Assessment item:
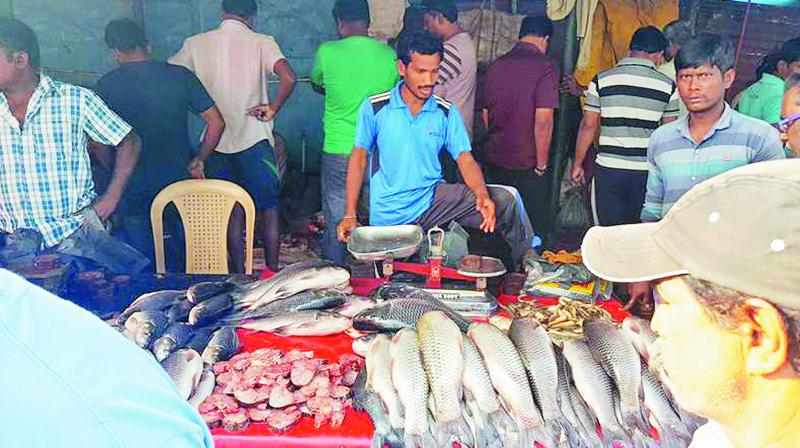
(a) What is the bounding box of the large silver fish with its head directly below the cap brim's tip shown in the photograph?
[583,319,650,439]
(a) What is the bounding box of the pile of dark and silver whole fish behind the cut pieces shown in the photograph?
[112,261,358,405]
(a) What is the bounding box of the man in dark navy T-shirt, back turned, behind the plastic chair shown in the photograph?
[96,19,225,271]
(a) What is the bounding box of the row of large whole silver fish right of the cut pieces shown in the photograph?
[353,286,700,448]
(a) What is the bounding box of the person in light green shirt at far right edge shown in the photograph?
[737,38,800,125]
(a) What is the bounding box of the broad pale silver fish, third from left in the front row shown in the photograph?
[417,311,473,445]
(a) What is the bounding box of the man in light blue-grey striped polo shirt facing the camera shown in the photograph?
[641,33,785,222]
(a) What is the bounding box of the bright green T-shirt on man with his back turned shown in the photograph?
[311,36,399,155]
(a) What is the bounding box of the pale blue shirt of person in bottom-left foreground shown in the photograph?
[0,270,213,448]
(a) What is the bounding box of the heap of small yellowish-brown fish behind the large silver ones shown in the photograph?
[504,297,613,338]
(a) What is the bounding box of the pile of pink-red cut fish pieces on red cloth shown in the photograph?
[199,349,363,431]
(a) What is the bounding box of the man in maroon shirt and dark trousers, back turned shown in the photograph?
[480,17,559,242]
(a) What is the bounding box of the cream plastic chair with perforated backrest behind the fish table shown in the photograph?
[150,179,256,275]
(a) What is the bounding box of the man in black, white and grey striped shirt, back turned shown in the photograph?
[572,26,679,226]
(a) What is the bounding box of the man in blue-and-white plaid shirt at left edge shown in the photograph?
[0,18,149,272]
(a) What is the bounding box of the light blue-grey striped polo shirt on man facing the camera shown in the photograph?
[642,104,785,222]
